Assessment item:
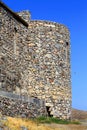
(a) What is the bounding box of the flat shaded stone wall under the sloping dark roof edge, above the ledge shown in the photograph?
[0,5,28,92]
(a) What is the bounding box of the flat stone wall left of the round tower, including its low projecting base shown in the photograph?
[0,4,46,118]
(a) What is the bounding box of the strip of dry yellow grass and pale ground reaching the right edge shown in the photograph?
[1,117,87,130]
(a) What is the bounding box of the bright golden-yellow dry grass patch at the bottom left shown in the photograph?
[4,117,56,130]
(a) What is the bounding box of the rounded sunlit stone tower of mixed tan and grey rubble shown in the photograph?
[28,21,71,119]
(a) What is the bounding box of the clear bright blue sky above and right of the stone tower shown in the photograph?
[3,0,87,110]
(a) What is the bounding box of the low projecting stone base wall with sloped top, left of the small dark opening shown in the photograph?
[0,93,47,118]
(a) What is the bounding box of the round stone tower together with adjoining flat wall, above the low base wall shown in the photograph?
[0,1,71,119]
